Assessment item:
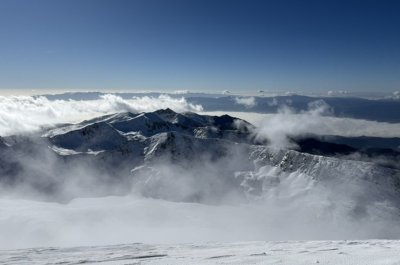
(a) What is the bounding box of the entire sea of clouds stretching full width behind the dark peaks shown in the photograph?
[0,94,400,140]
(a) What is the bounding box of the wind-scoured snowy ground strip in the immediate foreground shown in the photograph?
[0,240,400,265]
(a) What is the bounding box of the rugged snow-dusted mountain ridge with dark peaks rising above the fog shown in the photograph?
[0,109,400,211]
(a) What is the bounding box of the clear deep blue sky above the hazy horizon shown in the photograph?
[0,0,400,92]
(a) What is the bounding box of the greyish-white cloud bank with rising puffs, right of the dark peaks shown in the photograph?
[250,100,400,148]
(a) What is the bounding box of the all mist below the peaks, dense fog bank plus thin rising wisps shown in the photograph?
[0,132,400,248]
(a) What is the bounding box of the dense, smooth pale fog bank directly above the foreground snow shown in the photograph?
[0,189,400,249]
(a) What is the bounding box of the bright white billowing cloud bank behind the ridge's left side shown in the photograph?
[0,94,202,136]
